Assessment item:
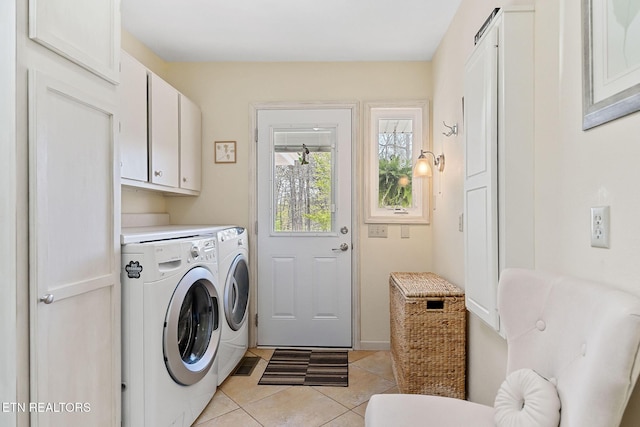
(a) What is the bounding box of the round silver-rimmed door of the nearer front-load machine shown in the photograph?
[163,267,221,385]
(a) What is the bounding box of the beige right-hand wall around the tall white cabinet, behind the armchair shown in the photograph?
[433,0,640,426]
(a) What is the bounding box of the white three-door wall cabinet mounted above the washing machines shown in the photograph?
[118,51,202,196]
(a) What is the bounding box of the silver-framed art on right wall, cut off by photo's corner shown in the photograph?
[582,0,640,130]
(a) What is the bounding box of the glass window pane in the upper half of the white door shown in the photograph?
[272,127,336,233]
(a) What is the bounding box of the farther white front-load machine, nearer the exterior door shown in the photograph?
[217,226,249,385]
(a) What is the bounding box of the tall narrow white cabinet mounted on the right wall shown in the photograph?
[464,7,534,331]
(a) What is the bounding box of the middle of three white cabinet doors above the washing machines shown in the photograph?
[149,74,179,187]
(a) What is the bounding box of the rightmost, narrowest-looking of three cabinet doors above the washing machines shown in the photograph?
[180,95,202,191]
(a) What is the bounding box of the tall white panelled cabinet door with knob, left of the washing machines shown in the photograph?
[28,70,121,427]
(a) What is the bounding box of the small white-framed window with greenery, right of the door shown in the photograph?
[364,101,429,224]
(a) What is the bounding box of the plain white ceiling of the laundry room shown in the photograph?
[121,0,461,62]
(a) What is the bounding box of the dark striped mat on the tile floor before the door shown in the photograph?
[258,349,349,387]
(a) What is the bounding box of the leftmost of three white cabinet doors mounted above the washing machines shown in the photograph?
[118,52,149,181]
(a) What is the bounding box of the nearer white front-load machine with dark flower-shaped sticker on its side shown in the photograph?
[121,227,224,427]
